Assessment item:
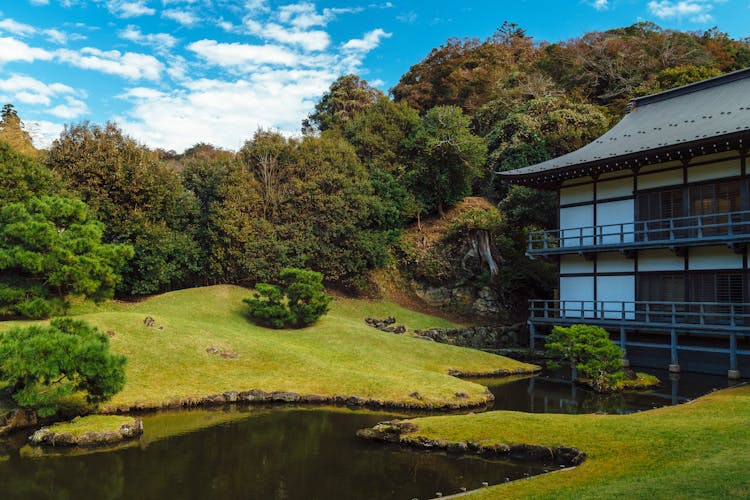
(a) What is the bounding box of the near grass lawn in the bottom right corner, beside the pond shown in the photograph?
[394,386,750,499]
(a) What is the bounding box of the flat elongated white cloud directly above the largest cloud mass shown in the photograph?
[187,39,302,67]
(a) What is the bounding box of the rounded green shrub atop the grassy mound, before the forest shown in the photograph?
[244,268,333,328]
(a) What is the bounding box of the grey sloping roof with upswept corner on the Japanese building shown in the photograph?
[498,68,750,185]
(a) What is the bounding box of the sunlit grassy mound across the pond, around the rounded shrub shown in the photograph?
[0,286,535,410]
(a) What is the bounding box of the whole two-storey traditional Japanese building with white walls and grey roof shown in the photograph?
[500,68,750,378]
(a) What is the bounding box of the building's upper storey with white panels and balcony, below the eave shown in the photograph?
[528,150,750,257]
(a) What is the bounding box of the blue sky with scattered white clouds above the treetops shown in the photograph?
[0,0,750,151]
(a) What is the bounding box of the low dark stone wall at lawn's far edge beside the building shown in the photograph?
[414,323,528,349]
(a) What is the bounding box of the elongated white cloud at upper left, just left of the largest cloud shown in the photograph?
[56,47,164,81]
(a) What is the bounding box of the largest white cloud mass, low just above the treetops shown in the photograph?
[118,70,337,151]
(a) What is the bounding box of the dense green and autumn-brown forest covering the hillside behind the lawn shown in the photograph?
[0,23,750,317]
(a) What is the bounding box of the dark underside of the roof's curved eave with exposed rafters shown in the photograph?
[497,130,750,189]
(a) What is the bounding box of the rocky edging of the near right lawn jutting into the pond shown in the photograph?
[357,420,586,467]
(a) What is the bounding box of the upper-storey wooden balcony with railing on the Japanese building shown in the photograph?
[526,210,750,258]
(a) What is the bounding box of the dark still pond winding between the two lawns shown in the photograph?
[0,374,727,500]
